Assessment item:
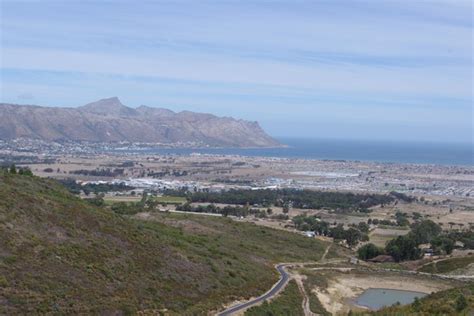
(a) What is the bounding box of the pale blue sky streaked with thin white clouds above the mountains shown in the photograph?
[0,0,474,143]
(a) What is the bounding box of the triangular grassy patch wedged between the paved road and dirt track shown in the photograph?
[245,281,304,316]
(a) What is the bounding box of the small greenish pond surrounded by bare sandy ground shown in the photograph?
[355,289,427,310]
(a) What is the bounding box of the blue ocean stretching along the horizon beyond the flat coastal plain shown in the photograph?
[121,138,474,166]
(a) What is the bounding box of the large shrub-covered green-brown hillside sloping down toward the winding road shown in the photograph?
[0,172,324,314]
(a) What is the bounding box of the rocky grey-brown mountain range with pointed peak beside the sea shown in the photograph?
[0,97,281,147]
